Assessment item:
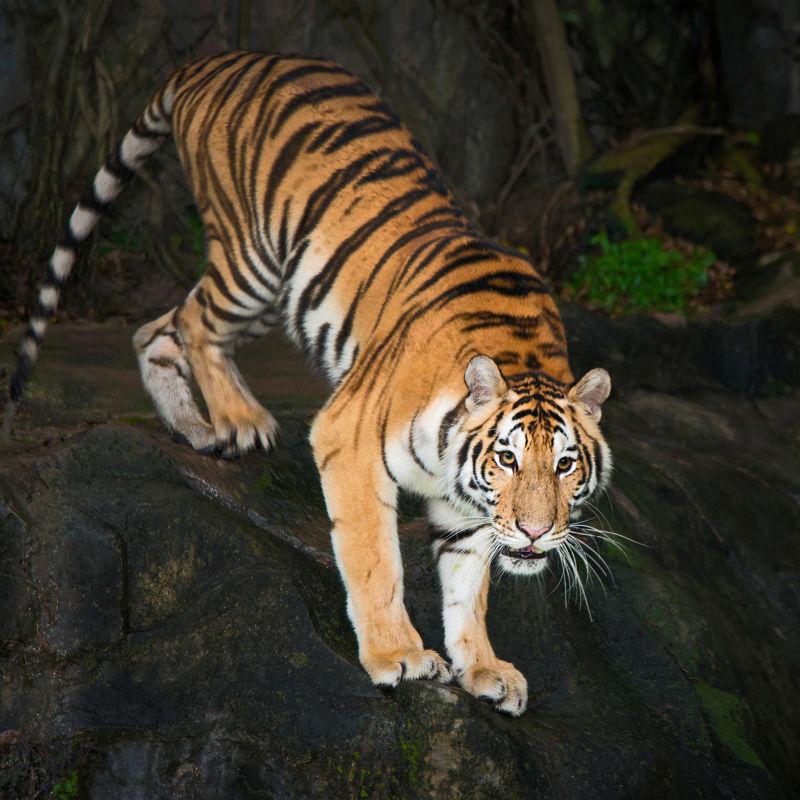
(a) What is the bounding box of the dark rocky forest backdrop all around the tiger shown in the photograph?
[0,0,800,800]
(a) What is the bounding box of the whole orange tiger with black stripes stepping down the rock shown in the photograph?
[4,52,612,716]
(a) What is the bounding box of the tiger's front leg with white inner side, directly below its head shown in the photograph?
[429,501,528,717]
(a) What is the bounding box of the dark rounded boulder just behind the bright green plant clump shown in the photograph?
[639,180,755,268]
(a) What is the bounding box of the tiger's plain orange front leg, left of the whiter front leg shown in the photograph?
[311,404,451,686]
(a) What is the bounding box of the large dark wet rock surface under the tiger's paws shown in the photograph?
[0,309,800,800]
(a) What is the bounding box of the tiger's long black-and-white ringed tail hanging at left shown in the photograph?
[2,75,178,438]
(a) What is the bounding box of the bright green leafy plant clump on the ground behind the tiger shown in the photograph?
[568,230,717,314]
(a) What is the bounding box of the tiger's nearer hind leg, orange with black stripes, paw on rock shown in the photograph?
[176,240,278,456]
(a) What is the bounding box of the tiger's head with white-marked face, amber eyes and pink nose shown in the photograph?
[448,356,612,575]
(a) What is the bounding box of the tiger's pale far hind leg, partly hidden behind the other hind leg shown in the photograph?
[133,308,216,450]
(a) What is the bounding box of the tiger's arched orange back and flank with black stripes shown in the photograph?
[173,53,566,396]
